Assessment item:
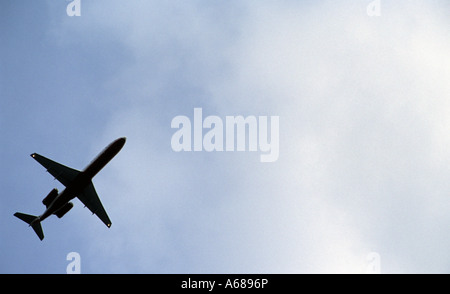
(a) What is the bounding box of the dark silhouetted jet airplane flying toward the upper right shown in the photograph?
[14,137,126,241]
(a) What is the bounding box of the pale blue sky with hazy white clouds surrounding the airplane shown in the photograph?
[0,0,450,274]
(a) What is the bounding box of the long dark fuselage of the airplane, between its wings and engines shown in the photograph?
[35,138,126,222]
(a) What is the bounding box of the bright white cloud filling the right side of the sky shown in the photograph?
[206,3,450,272]
